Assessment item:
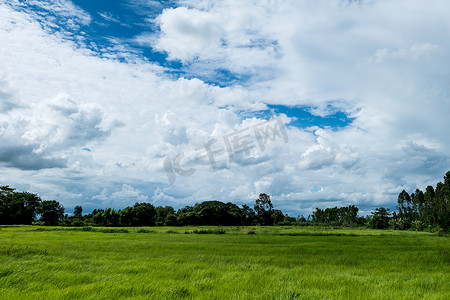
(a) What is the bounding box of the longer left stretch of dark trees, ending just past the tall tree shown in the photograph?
[0,191,296,226]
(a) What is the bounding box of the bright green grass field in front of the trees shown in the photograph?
[0,226,450,299]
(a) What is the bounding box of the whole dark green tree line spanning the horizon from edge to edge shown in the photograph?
[0,171,450,230]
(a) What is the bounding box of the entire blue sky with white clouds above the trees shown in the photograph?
[0,0,450,215]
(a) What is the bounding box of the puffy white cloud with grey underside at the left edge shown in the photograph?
[0,91,109,170]
